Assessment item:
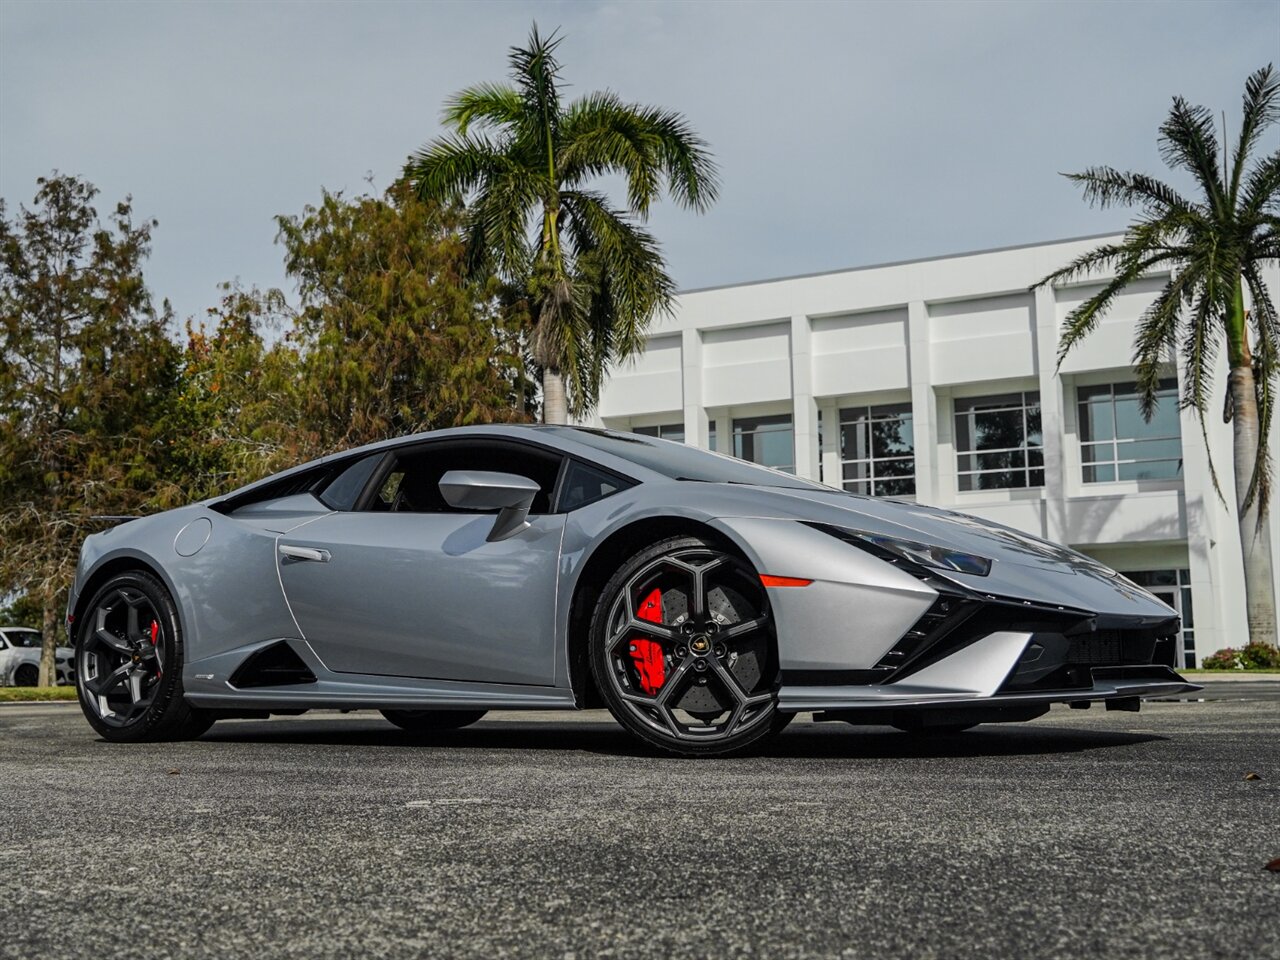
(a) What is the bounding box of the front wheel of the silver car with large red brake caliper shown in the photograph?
[589,536,792,756]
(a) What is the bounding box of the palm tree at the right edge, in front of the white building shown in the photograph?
[1037,64,1280,644]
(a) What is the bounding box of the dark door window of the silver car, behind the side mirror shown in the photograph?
[369,440,563,515]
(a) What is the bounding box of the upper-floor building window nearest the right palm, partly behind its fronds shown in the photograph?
[1076,379,1183,484]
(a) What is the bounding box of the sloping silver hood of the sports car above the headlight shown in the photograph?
[727,488,1175,621]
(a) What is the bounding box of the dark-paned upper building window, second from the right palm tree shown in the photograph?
[955,390,1044,490]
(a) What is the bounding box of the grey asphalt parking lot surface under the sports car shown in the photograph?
[0,684,1280,960]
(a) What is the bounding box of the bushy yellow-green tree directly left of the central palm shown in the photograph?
[270,183,526,453]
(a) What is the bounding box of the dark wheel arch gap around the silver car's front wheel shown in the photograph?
[566,515,754,709]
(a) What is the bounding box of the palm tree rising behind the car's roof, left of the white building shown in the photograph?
[407,24,717,424]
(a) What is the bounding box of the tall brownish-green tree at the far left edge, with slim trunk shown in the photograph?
[0,174,178,684]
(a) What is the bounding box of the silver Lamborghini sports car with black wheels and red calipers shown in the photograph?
[67,426,1198,755]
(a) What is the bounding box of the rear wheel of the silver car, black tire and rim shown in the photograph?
[76,570,215,744]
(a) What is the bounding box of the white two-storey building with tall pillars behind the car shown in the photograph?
[593,237,1280,666]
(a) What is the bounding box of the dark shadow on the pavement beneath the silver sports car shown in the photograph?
[201,717,1167,759]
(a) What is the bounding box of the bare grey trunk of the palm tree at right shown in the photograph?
[1228,365,1280,646]
